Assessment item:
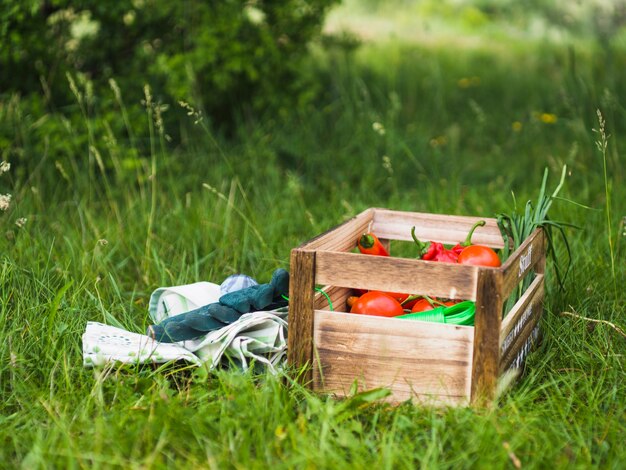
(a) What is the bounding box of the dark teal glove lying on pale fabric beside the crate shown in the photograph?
[146,269,289,343]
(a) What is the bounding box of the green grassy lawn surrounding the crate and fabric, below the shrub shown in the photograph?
[0,6,626,469]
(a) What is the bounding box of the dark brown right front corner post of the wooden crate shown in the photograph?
[471,269,503,405]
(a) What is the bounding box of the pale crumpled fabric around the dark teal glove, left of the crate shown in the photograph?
[83,271,289,372]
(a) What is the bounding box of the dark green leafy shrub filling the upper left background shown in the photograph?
[0,0,335,182]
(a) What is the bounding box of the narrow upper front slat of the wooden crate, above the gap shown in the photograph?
[315,251,476,300]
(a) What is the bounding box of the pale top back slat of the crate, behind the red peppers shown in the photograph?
[372,209,504,248]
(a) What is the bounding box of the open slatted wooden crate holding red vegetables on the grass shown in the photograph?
[288,208,546,404]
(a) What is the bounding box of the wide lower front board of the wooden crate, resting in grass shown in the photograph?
[313,310,473,403]
